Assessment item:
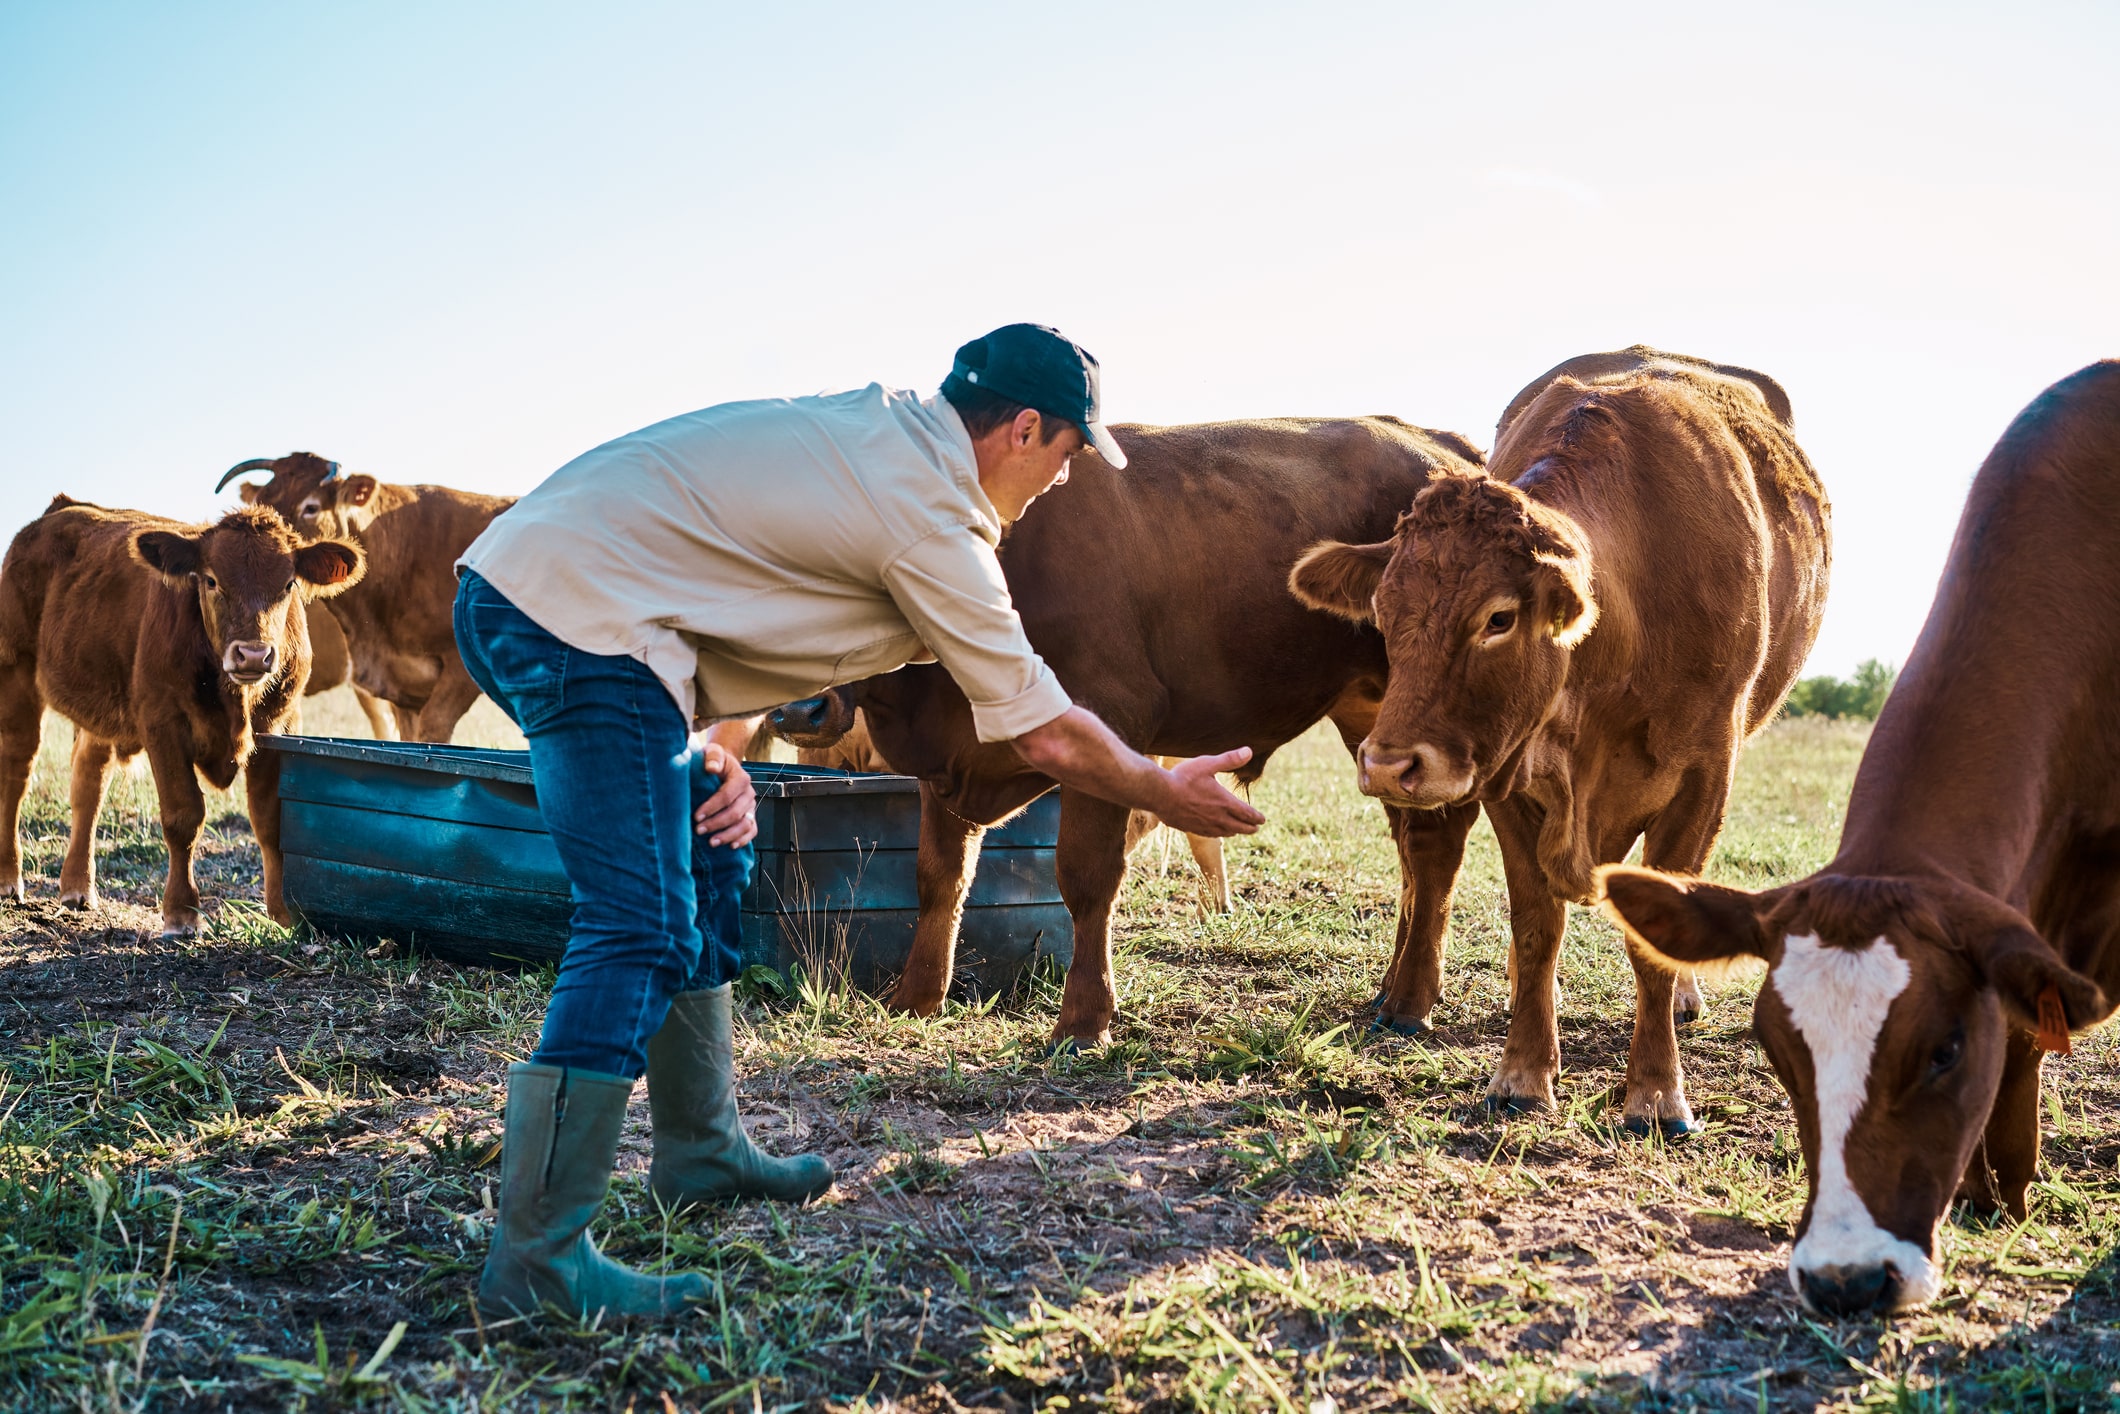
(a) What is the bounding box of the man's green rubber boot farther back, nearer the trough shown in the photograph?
[649,984,831,1208]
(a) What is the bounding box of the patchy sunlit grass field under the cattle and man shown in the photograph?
[0,697,2120,1414]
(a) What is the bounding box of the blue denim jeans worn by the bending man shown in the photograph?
[456,570,757,1077]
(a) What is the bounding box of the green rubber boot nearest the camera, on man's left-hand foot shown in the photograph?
[479,1064,708,1321]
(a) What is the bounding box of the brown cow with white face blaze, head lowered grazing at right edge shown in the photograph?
[1598,360,2120,1312]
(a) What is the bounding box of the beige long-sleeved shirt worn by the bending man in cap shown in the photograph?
[458,384,1071,742]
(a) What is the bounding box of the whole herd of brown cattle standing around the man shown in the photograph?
[0,346,2120,1312]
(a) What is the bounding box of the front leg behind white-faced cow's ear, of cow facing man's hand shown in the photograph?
[1620,753,1734,1138]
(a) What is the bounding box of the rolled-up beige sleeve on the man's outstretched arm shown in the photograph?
[884,526,1075,742]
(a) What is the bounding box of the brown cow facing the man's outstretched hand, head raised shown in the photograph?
[1289,350,1827,1134]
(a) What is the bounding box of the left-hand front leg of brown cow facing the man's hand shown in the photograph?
[1486,797,1569,1113]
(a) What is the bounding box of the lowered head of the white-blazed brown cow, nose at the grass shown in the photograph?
[1601,867,2107,1314]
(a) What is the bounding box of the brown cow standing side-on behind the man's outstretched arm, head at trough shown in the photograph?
[771,418,1480,1045]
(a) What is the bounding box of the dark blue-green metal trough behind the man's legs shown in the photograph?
[259,736,1075,994]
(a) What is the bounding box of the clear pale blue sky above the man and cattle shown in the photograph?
[0,0,2120,672]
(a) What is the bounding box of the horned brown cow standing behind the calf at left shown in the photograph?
[214,452,515,742]
